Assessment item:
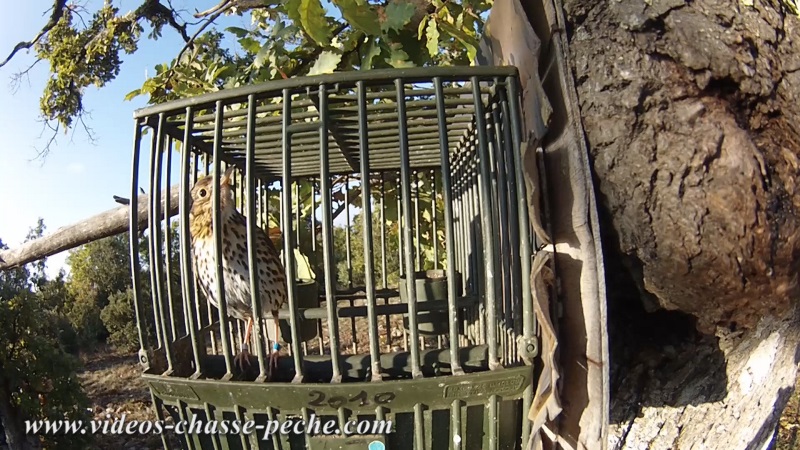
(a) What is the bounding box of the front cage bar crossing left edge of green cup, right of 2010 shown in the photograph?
[394,78,422,380]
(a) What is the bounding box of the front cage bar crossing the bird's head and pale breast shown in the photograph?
[211,101,233,381]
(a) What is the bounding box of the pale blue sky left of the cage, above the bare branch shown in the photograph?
[0,0,249,274]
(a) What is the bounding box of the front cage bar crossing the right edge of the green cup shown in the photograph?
[433,77,464,375]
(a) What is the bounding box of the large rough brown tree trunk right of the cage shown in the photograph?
[564,0,800,449]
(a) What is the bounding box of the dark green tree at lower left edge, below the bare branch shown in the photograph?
[0,220,90,449]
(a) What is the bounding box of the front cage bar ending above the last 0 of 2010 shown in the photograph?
[357,81,382,381]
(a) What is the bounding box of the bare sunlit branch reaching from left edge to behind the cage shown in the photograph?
[0,185,180,270]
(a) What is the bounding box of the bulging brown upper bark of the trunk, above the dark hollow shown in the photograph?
[565,0,800,332]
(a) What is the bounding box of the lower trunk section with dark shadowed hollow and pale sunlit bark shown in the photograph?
[609,304,800,450]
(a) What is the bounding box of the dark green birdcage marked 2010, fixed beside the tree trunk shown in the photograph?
[130,67,537,449]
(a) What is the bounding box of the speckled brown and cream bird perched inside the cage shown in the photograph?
[189,166,286,376]
